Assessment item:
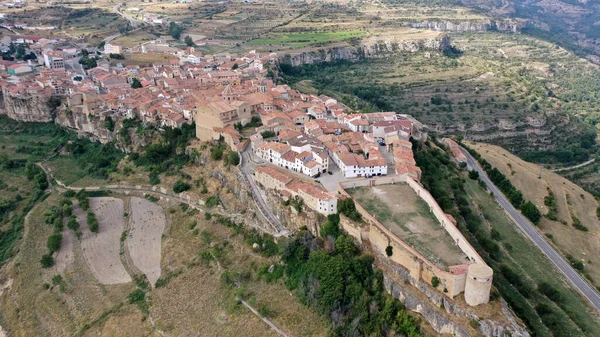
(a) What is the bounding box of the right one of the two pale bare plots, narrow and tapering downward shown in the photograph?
[127,197,167,285]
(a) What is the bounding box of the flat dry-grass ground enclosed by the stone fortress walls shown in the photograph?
[348,184,468,269]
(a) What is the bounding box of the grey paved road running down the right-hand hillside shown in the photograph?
[460,147,600,312]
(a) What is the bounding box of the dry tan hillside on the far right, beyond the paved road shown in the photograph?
[467,142,600,284]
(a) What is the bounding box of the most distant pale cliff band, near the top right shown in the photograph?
[407,19,527,34]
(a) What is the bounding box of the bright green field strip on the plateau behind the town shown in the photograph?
[248,30,367,48]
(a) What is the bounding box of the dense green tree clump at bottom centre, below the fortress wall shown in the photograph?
[282,219,423,337]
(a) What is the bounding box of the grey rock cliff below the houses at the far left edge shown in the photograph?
[0,88,56,122]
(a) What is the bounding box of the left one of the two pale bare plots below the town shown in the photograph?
[75,197,131,284]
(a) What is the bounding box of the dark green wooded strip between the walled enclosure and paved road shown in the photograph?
[413,142,593,337]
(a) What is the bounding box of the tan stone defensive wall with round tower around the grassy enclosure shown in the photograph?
[338,175,493,306]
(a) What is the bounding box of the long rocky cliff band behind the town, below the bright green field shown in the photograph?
[279,34,450,66]
